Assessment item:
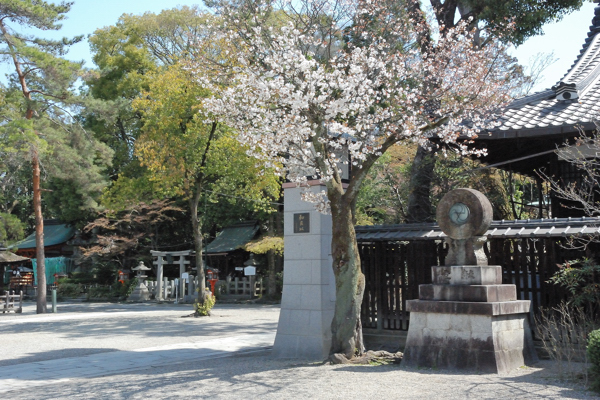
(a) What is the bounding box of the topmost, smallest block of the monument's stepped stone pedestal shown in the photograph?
[431,265,502,285]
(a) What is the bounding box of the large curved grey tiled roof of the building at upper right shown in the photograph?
[481,3,600,139]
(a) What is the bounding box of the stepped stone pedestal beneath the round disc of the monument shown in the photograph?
[402,265,537,374]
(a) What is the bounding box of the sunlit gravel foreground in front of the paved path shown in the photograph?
[7,353,598,400]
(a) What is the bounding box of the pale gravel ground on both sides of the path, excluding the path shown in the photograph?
[0,304,599,400]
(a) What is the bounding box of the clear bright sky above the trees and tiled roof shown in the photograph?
[3,0,596,90]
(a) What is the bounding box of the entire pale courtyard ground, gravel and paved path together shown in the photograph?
[0,303,598,400]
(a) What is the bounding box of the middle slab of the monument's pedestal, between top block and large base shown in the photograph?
[419,285,517,302]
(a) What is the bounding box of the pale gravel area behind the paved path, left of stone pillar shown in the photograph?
[0,303,279,366]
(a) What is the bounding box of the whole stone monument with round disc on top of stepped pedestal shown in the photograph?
[402,189,537,374]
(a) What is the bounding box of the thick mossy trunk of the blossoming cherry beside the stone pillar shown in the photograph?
[330,196,365,358]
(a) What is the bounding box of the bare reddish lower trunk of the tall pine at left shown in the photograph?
[31,149,48,314]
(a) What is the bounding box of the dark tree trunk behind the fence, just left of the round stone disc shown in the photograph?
[406,146,435,224]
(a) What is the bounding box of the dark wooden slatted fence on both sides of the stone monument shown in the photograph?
[358,238,593,330]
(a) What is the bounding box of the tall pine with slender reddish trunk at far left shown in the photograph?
[0,0,91,313]
